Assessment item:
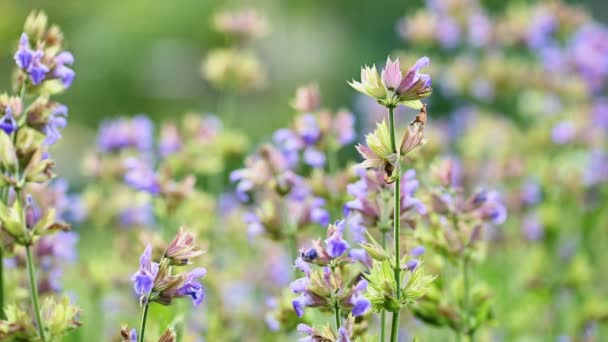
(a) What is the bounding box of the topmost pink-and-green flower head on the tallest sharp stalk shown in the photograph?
[349,57,432,109]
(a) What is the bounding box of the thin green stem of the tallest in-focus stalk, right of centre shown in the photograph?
[388,107,401,342]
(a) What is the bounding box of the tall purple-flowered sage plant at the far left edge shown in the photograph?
[0,11,79,342]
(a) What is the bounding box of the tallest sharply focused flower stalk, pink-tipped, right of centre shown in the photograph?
[349,57,432,341]
